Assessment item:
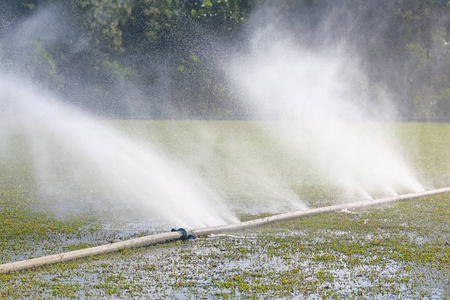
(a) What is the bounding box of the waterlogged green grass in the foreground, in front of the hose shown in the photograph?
[0,194,450,299]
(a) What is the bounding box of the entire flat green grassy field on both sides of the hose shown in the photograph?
[0,121,450,299]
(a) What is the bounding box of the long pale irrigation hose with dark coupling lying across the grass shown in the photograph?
[0,187,450,274]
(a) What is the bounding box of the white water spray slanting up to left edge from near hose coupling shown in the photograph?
[0,76,237,227]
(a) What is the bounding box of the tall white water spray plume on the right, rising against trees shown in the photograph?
[227,28,423,198]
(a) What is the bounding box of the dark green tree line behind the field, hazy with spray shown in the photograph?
[0,0,450,118]
